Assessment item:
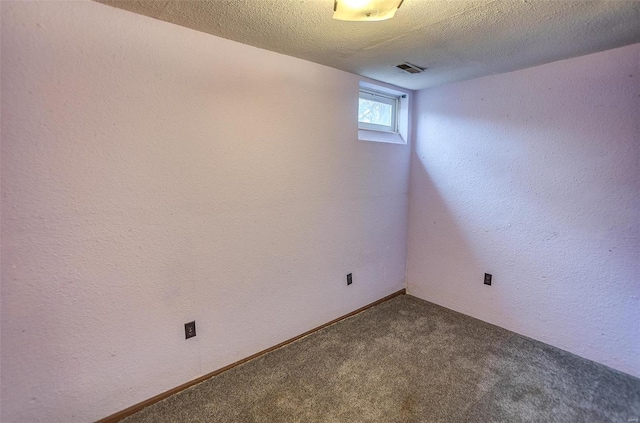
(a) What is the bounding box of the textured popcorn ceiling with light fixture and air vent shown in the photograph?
[98,0,640,89]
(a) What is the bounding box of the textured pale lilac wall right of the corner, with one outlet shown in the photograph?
[407,44,640,376]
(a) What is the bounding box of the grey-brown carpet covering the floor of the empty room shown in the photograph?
[124,295,640,423]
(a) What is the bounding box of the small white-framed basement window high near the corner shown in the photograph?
[358,89,399,132]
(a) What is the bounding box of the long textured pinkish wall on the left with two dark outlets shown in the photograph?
[1,2,410,423]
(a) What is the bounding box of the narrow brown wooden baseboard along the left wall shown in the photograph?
[96,289,407,423]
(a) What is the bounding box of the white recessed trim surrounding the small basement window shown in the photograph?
[356,81,410,144]
